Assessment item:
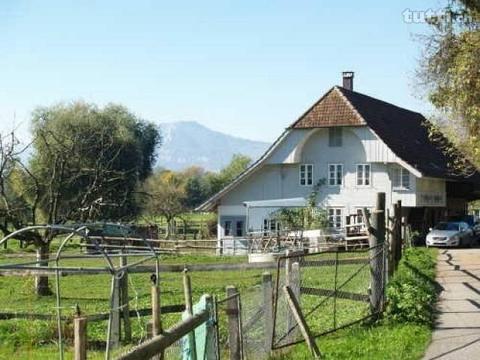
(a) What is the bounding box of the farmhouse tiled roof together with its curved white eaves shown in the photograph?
[198,86,480,210]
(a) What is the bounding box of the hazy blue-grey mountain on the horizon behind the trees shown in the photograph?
[157,121,269,171]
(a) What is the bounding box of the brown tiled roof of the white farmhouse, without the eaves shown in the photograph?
[291,86,480,182]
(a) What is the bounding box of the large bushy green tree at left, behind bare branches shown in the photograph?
[0,102,160,295]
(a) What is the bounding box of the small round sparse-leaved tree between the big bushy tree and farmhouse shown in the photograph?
[143,170,186,239]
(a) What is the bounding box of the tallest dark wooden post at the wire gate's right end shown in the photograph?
[368,192,385,314]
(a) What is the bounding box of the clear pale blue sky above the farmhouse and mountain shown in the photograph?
[0,0,443,141]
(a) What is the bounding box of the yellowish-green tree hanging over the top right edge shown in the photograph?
[419,0,480,167]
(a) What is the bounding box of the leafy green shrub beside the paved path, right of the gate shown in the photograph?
[386,248,437,325]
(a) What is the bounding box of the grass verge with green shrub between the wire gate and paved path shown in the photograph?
[275,248,437,360]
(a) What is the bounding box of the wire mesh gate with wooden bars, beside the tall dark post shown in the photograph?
[273,245,385,349]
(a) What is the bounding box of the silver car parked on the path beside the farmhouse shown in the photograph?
[426,221,474,247]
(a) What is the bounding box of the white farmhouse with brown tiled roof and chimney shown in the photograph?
[199,72,480,245]
